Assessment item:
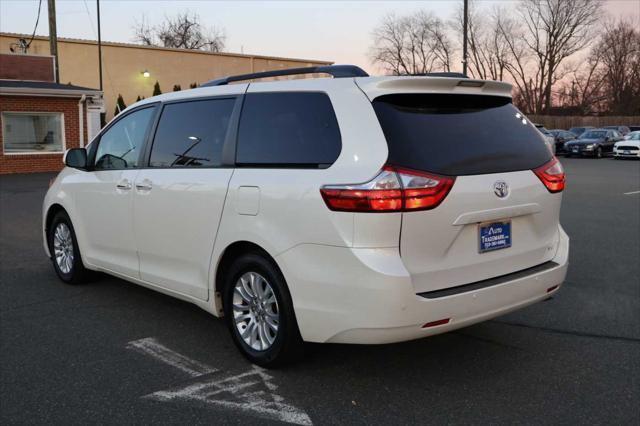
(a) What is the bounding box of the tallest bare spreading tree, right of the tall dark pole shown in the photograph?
[502,0,601,113]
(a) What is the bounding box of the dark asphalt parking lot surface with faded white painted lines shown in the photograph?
[0,159,640,425]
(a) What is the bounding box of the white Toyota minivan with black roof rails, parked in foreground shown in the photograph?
[43,66,569,366]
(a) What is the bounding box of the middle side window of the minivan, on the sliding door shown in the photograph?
[149,98,236,167]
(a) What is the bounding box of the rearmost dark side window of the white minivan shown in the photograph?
[236,92,342,168]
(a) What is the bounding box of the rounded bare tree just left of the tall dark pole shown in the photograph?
[371,11,454,75]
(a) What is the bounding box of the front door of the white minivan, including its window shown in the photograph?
[75,106,156,277]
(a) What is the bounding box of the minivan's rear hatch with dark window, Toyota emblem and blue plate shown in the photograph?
[373,88,561,293]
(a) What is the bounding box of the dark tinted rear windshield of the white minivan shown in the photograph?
[373,94,551,176]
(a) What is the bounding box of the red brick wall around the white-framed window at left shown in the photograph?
[0,95,87,174]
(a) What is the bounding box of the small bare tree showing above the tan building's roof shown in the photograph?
[133,12,226,52]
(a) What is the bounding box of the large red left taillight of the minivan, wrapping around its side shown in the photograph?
[320,166,455,213]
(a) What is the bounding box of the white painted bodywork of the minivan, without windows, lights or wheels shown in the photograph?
[43,73,568,343]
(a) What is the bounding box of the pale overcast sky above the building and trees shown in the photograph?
[0,0,640,71]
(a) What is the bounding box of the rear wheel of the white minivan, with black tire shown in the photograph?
[222,252,303,368]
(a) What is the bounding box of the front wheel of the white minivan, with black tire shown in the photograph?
[47,211,90,284]
